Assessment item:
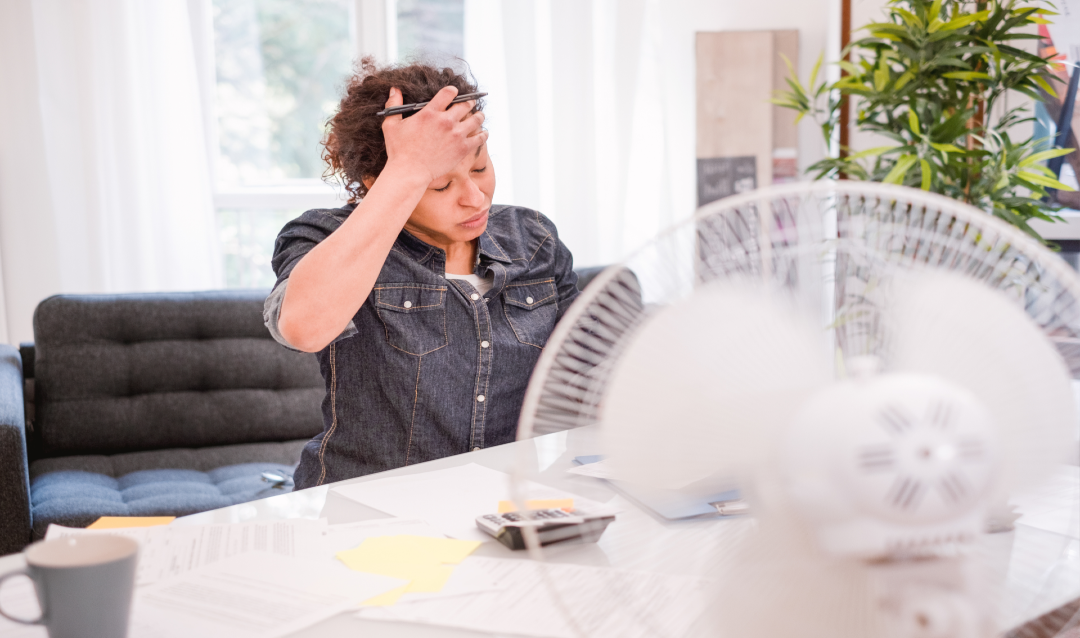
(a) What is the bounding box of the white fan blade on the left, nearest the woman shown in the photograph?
[602,283,832,489]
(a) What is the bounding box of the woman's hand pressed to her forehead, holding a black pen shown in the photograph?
[382,86,487,181]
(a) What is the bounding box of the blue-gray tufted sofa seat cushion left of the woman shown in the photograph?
[30,439,307,539]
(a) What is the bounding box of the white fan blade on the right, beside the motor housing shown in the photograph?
[886,272,1077,496]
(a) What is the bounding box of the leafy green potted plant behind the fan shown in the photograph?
[773,0,1072,237]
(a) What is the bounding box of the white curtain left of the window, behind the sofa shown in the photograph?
[0,0,221,341]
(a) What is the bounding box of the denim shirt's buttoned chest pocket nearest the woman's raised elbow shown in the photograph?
[375,283,447,355]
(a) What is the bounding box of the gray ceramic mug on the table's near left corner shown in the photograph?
[0,534,138,638]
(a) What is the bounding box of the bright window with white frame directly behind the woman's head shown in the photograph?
[207,0,464,287]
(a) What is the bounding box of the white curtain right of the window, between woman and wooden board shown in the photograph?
[464,0,693,266]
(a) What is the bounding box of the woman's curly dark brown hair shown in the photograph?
[322,56,484,203]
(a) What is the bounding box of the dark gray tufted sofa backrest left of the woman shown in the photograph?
[33,290,325,454]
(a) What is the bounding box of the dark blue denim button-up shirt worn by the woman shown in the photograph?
[266,205,578,489]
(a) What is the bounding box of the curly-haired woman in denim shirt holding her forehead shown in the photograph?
[266,58,577,489]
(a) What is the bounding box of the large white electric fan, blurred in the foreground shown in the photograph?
[518,182,1080,638]
